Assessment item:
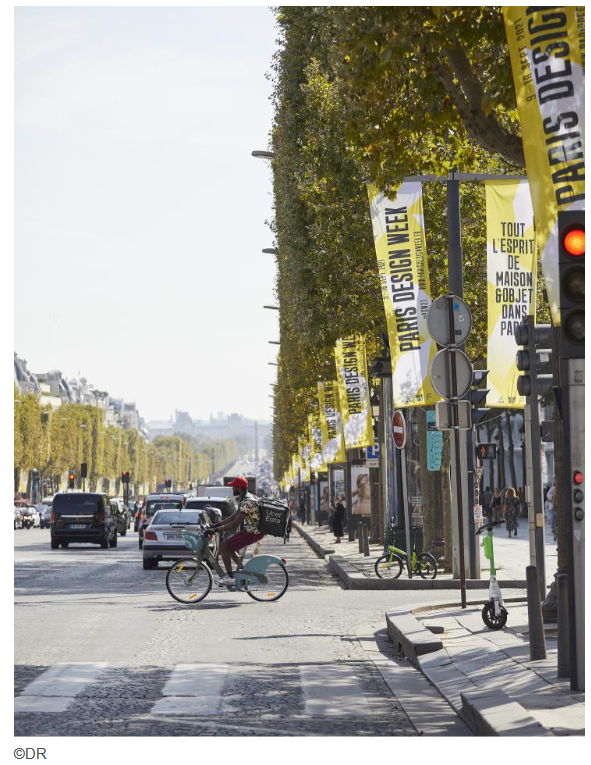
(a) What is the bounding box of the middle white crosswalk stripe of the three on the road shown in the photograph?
[152,664,229,715]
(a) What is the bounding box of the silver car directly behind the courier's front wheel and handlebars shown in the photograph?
[143,508,219,569]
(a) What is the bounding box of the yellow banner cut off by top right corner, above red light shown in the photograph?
[503,5,585,326]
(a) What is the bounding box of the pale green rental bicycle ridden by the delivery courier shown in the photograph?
[166,525,289,606]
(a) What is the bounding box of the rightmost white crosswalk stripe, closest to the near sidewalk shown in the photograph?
[300,664,371,717]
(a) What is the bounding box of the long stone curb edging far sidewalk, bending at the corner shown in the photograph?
[293,523,527,590]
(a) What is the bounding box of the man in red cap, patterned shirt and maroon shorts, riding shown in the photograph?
[211,475,264,587]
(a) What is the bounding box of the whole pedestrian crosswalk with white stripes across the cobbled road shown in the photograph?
[15,662,410,719]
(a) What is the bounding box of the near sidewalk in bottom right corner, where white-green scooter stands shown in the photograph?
[386,604,585,736]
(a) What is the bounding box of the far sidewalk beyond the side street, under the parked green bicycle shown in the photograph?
[293,518,556,594]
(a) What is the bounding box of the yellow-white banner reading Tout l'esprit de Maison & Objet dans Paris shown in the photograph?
[485,180,536,409]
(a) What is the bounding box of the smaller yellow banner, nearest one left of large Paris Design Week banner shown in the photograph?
[334,335,374,449]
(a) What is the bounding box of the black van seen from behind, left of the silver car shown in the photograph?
[51,492,117,550]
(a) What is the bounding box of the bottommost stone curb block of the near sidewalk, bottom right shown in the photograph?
[460,690,554,737]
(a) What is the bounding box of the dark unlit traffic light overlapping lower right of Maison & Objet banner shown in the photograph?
[515,316,552,400]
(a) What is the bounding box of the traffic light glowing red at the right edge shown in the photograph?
[558,210,585,359]
